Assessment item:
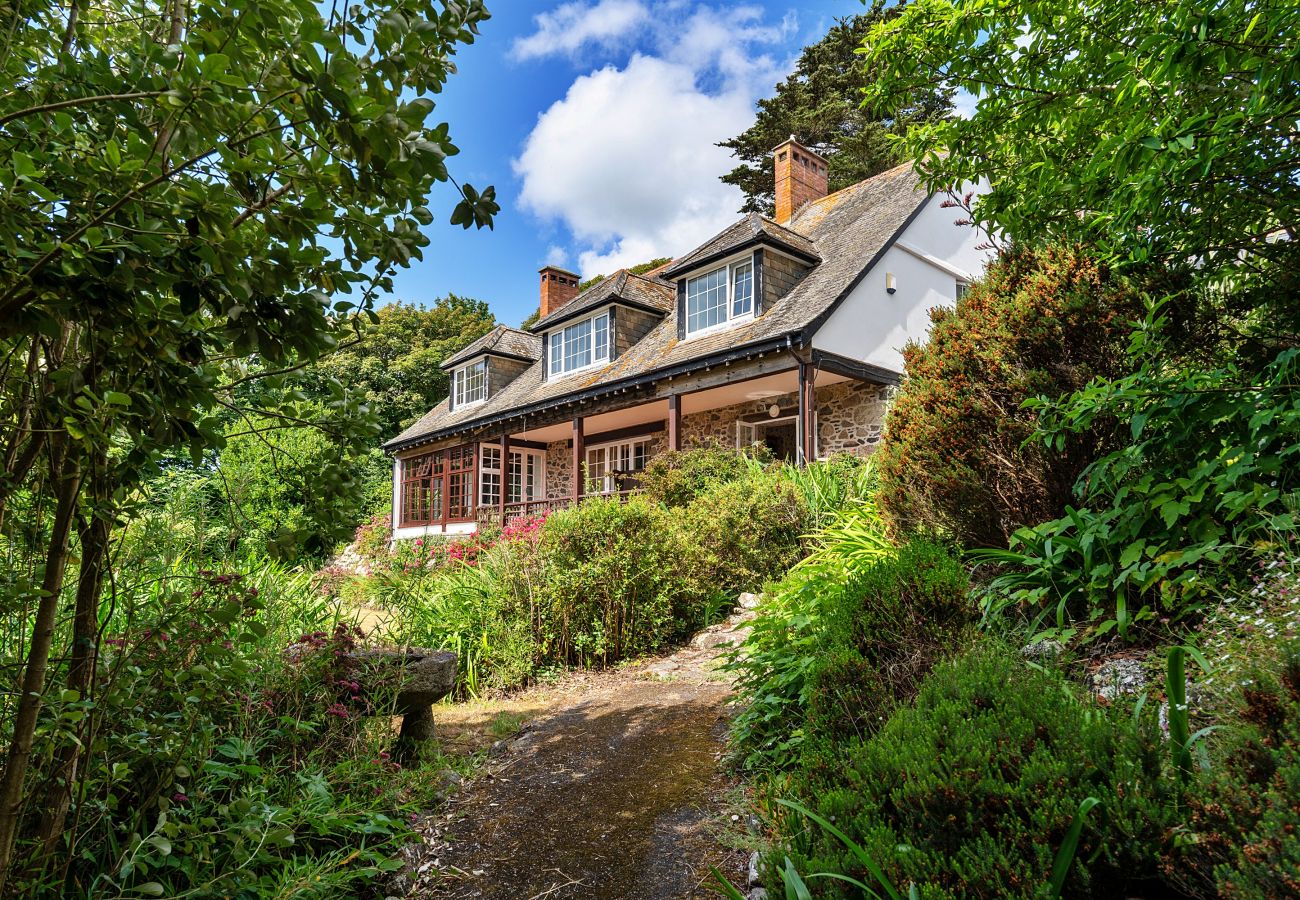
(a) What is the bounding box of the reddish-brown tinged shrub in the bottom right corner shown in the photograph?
[1173,641,1300,900]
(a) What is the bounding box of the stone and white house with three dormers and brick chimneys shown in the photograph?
[385,138,987,538]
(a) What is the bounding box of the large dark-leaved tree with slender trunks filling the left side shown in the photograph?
[0,0,498,893]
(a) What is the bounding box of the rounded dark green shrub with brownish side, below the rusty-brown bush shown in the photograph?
[809,538,974,756]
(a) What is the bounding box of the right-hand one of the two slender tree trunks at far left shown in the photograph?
[38,454,112,860]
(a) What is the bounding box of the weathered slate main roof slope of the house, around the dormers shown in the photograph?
[385,164,927,450]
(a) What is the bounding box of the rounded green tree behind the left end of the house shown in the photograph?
[311,294,497,437]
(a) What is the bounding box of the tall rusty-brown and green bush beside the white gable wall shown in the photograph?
[876,247,1141,546]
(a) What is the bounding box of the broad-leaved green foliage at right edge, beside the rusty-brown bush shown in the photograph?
[980,340,1300,636]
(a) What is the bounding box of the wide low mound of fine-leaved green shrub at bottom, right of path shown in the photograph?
[770,645,1174,897]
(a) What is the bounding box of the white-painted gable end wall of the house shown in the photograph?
[813,185,993,375]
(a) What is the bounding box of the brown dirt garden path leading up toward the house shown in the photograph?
[400,611,753,900]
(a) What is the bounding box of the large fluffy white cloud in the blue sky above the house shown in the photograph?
[515,3,792,276]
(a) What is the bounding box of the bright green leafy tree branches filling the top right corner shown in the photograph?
[863,0,1300,284]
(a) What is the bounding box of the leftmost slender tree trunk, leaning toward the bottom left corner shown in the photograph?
[0,432,81,896]
